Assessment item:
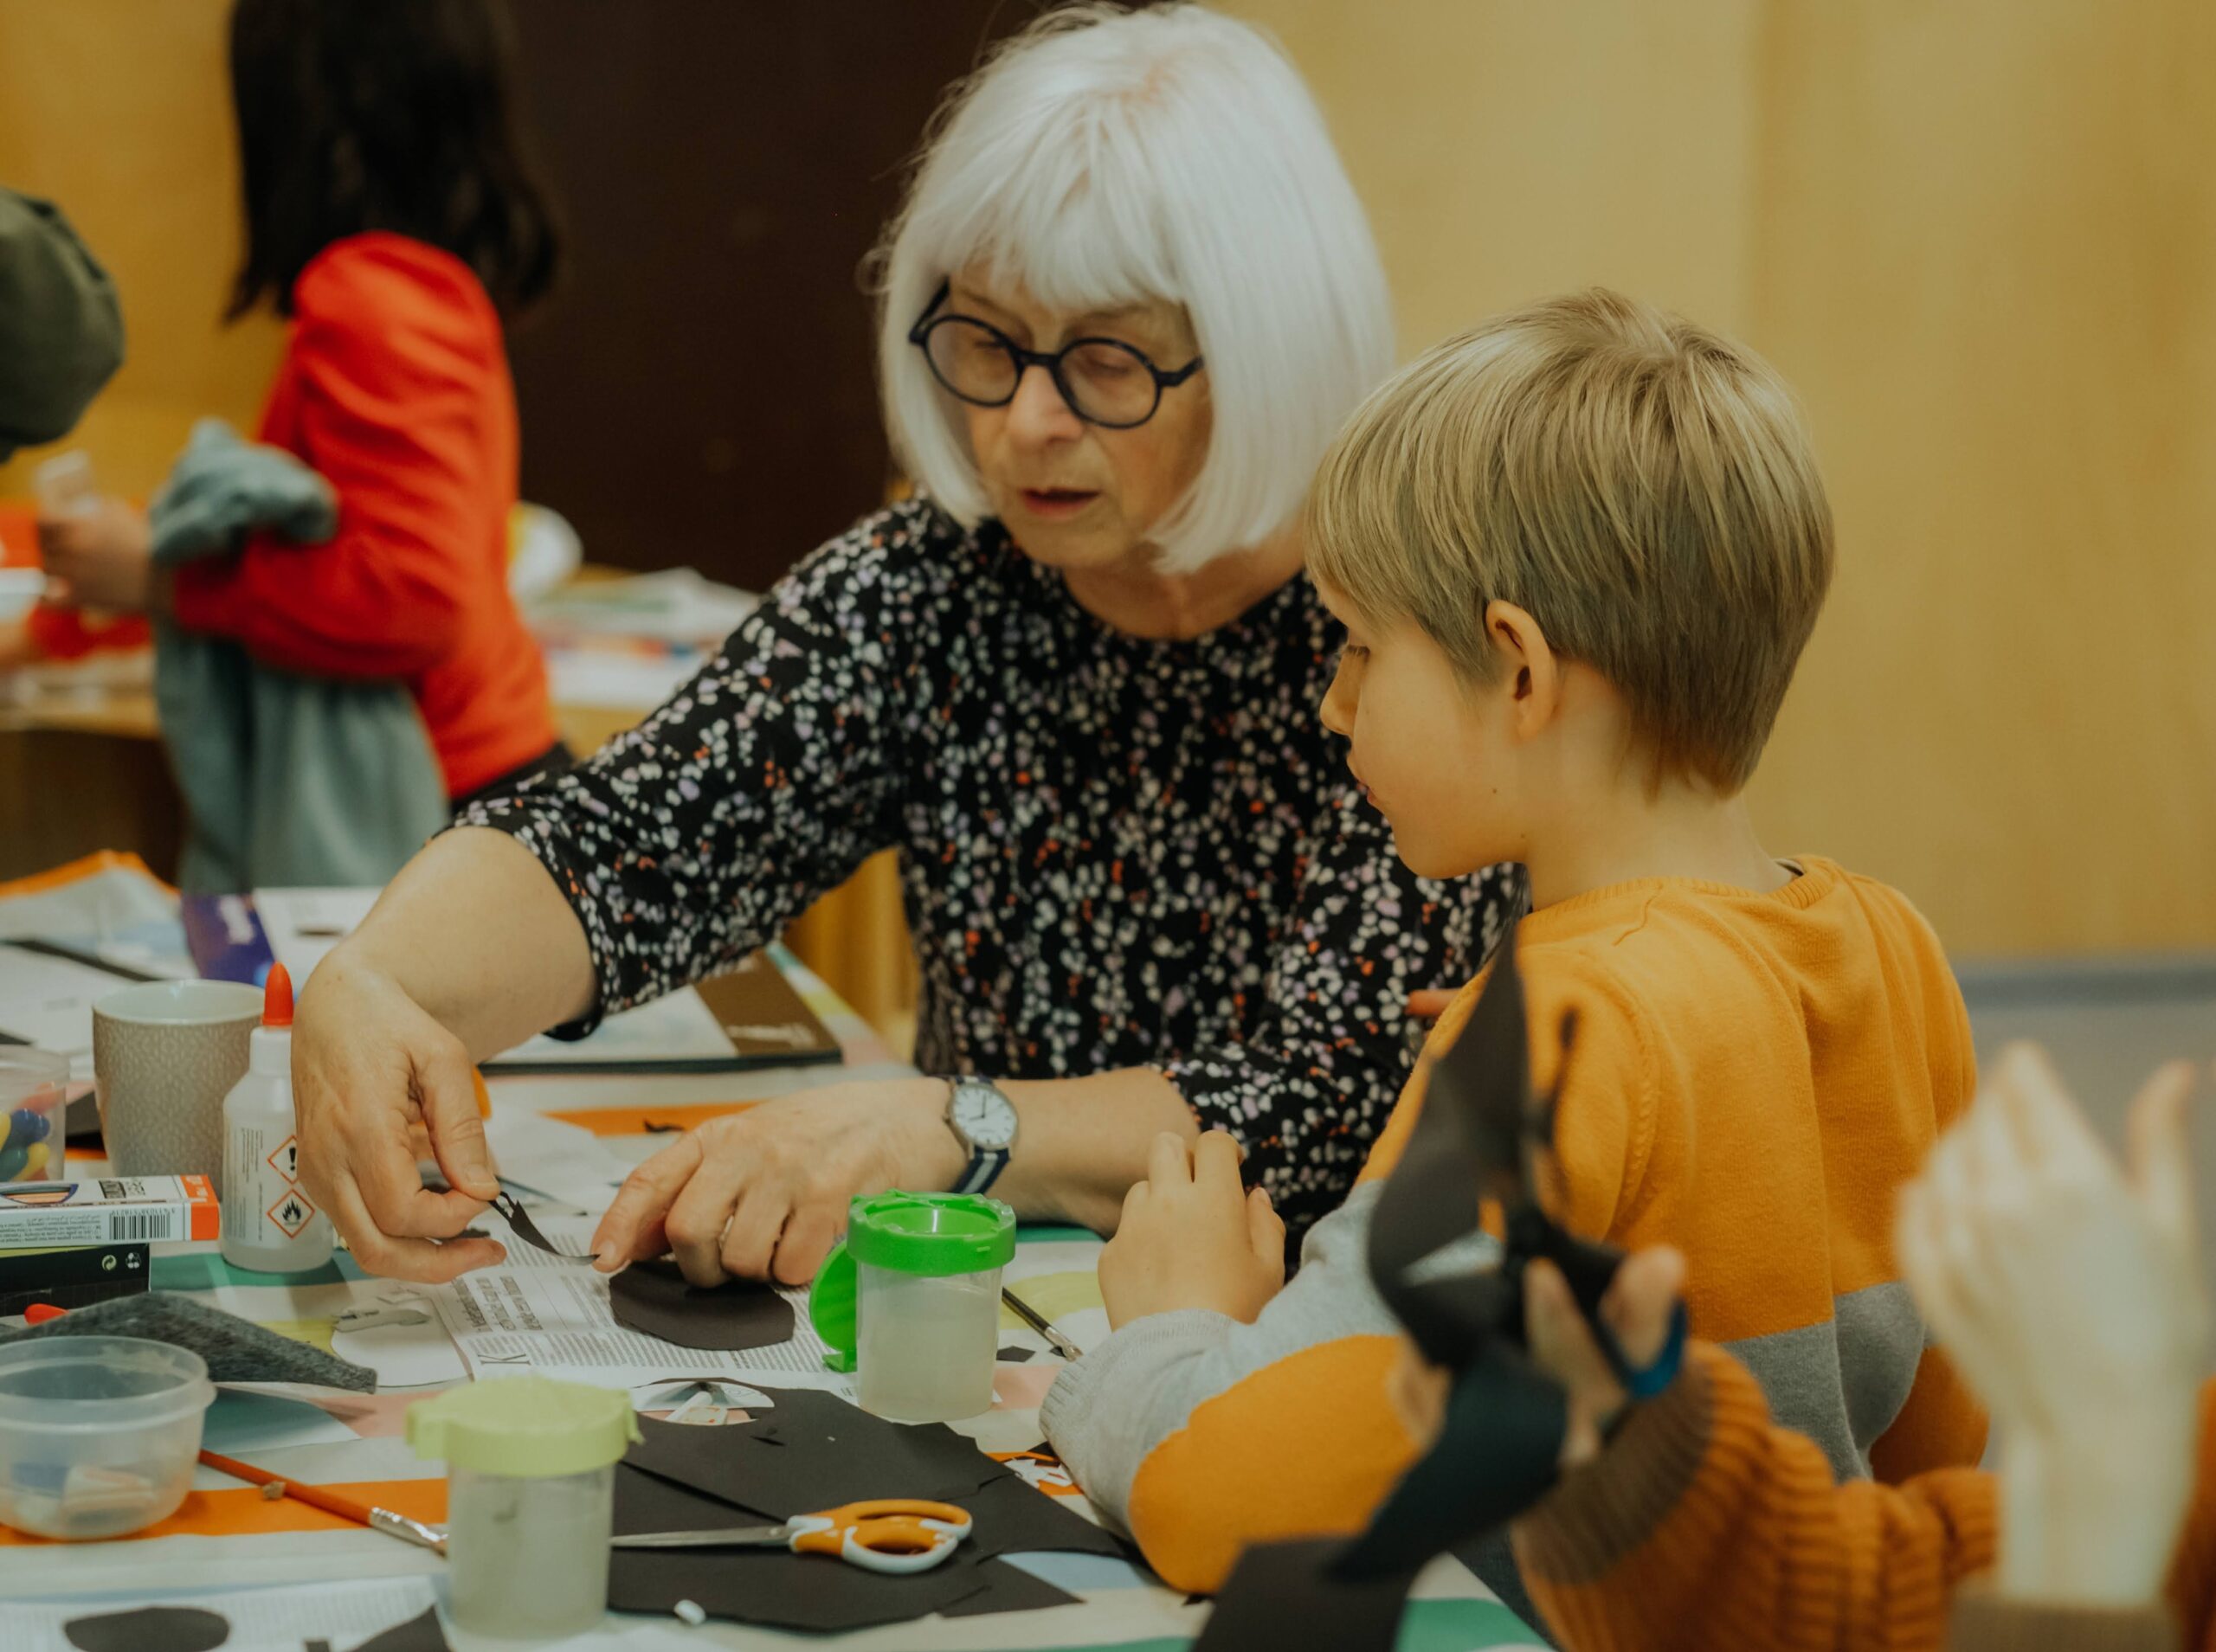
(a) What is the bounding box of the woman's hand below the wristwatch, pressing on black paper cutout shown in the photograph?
[592,1078,969,1287]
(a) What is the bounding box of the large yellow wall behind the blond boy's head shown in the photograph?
[1227,0,2216,955]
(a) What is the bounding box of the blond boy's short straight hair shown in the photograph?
[1307,288,1833,793]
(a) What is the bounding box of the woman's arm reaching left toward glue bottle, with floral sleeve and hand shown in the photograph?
[293,511,926,1280]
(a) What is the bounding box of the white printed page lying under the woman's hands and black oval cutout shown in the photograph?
[426,1218,854,1398]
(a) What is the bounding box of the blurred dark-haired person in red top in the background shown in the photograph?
[40,0,565,810]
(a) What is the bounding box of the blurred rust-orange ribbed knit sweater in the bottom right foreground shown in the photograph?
[1516,1344,2216,1652]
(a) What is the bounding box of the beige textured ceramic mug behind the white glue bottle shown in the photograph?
[93,981,261,1178]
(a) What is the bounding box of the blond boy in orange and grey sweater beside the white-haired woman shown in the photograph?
[1044,290,1983,1590]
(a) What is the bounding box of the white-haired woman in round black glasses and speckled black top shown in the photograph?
[294,9,1511,1284]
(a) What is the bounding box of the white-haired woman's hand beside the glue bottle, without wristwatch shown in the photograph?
[293,952,506,1282]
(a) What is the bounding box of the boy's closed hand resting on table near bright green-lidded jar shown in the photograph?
[1101,1129,1285,1328]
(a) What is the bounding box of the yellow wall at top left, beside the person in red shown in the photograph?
[0,0,284,498]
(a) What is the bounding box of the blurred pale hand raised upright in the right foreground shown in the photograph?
[1895,1045,2207,1605]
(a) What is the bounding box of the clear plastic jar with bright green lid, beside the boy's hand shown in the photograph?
[808,1192,1015,1422]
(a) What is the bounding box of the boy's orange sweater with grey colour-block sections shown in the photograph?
[1041,859,1986,1590]
